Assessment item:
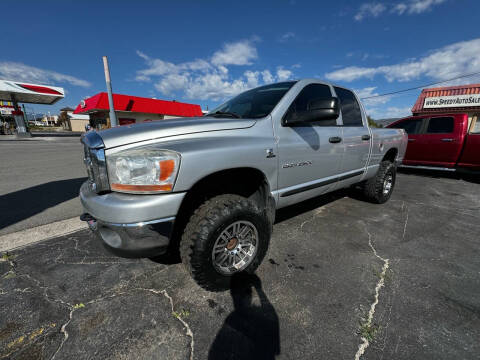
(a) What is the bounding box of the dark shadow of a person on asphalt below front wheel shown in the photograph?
[208,273,280,360]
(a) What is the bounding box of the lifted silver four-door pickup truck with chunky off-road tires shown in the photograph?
[80,79,407,290]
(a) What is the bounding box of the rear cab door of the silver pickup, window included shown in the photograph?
[333,86,371,188]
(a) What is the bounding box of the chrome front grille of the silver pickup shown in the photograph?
[81,132,110,193]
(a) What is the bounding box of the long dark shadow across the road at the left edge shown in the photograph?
[0,178,87,229]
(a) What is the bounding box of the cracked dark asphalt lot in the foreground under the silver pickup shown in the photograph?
[0,173,480,359]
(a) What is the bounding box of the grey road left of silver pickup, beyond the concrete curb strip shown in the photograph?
[0,136,86,236]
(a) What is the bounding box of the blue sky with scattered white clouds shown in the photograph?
[0,0,480,119]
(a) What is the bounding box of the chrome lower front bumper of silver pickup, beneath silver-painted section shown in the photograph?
[80,213,175,257]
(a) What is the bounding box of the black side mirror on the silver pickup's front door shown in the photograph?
[284,97,340,126]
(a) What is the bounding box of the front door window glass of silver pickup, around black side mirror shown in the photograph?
[285,84,337,126]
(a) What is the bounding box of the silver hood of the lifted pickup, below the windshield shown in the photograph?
[98,117,256,149]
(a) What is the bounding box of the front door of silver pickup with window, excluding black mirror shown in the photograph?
[274,83,344,207]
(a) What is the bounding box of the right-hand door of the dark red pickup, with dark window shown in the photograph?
[423,116,468,167]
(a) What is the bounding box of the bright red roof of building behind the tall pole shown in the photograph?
[74,92,202,116]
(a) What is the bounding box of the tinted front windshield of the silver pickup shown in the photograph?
[205,81,296,119]
